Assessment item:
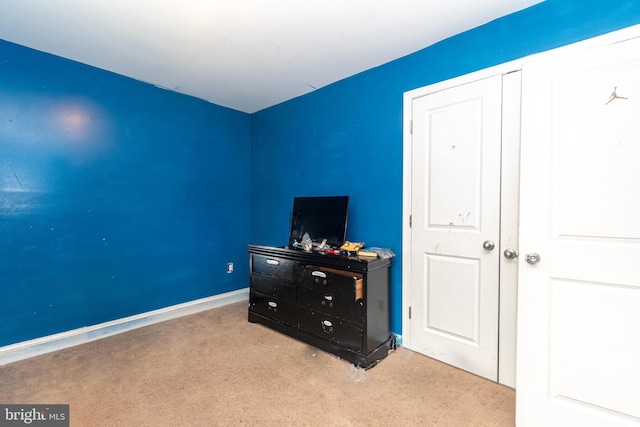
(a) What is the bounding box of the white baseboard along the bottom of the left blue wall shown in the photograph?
[0,288,249,366]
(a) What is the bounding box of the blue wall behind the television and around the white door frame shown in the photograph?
[252,0,640,333]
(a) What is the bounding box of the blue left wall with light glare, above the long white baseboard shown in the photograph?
[0,41,251,346]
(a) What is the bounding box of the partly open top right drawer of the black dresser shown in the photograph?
[301,265,364,301]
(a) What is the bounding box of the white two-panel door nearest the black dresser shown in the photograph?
[410,76,502,380]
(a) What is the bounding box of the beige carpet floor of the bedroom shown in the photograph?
[0,303,515,427]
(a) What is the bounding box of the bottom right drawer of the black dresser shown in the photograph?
[298,308,363,351]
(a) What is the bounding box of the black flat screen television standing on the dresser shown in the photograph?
[289,196,349,247]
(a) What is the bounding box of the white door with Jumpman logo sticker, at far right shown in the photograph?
[517,34,640,427]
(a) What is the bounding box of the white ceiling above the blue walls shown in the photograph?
[0,0,540,113]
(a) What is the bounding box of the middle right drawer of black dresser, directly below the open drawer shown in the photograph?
[298,286,364,324]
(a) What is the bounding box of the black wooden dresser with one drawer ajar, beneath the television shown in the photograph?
[249,245,396,369]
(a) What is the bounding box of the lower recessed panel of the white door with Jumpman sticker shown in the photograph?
[549,279,640,417]
